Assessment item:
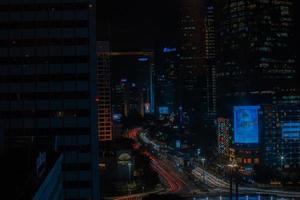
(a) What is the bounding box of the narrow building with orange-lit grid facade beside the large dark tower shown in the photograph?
[97,42,112,141]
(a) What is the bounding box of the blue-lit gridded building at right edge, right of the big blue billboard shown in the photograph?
[260,104,300,168]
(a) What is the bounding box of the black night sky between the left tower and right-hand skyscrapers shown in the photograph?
[97,0,178,51]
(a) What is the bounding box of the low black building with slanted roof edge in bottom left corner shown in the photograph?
[0,139,64,200]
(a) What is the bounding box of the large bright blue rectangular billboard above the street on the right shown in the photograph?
[234,106,260,144]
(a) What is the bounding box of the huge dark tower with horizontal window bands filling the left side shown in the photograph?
[0,0,99,200]
